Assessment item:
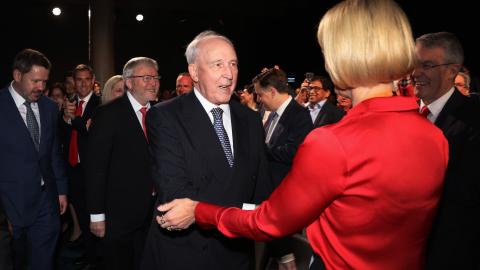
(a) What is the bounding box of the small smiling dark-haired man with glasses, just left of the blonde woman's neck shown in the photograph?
[306,75,345,128]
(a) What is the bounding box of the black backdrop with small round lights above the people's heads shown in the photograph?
[0,0,480,89]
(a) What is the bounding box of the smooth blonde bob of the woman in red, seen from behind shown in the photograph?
[317,0,416,89]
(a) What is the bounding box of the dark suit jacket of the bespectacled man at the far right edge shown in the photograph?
[428,90,480,269]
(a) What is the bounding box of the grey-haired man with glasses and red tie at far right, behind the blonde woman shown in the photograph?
[413,32,480,270]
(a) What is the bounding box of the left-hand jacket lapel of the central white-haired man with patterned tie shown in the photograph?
[181,92,230,179]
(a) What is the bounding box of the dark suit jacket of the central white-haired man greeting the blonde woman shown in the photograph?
[142,92,271,270]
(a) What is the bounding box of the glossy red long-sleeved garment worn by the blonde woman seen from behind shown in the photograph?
[195,97,448,269]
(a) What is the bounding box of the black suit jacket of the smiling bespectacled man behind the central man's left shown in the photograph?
[84,94,153,238]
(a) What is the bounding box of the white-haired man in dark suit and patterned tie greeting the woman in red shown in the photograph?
[142,31,271,270]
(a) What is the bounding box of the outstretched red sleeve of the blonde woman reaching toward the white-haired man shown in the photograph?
[195,128,348,241]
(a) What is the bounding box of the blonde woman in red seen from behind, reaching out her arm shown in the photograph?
[157,0,448,270]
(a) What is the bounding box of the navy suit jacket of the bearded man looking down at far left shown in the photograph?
[0,87,67,227]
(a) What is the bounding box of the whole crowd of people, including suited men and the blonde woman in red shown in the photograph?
[0,0,480,270]
